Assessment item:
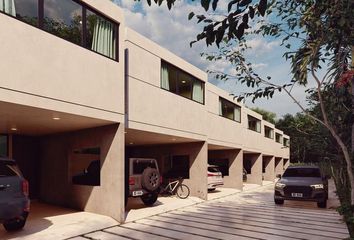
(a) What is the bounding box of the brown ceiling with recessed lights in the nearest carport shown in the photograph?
[0,101,112,136]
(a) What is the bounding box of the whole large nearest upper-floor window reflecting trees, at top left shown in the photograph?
[0,0,118,60]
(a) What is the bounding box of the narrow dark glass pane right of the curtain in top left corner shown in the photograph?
[15,0,38,26]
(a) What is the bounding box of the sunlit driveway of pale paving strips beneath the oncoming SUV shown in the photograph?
[68,185,348,240]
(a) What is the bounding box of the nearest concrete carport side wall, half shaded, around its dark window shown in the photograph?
[40,124,125,223]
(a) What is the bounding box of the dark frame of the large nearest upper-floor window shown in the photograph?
[0,0,120,62]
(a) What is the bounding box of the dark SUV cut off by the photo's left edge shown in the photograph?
[0,158,30,231]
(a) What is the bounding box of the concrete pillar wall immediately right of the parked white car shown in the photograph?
[208,149,243,190]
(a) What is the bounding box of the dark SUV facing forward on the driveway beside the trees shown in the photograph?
[274,166,328,208]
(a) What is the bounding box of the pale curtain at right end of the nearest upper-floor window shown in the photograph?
[92,17,116,59]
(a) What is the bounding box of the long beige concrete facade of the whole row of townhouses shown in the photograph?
[0,0,290,222]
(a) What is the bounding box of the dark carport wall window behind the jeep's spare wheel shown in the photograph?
[164,155,189,179]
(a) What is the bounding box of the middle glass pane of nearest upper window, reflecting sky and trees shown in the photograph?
[43,0,82,44]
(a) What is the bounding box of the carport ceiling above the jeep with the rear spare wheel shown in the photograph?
[125,129,200,146]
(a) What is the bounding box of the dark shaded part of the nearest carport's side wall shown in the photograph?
[40,125,118,210]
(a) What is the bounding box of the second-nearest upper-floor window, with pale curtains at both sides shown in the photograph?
[161,61,204,104]
